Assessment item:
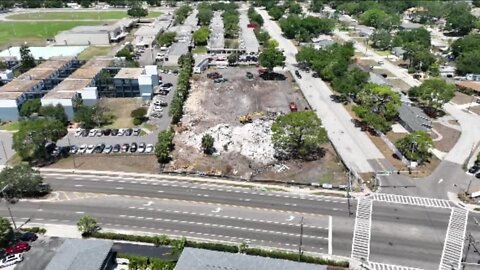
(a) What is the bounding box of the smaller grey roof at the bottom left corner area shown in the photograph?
[45,239,113,270]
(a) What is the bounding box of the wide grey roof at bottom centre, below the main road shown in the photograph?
[175,247,327,270]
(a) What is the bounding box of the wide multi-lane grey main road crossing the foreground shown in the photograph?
[0,173,464,269]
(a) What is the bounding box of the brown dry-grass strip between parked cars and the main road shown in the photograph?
[48,155,159,173]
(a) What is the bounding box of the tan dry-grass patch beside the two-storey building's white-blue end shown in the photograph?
[102,98,142,128]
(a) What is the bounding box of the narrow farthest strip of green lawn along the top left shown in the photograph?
[7,11,161,21]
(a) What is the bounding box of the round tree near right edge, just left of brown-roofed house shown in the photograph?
[408,79,455,113]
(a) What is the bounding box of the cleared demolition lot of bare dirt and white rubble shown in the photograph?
[164,67,346,184]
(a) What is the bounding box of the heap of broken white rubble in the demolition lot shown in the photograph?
[182,119,275,164]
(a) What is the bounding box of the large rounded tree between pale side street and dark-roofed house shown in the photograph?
[353,84,400,132]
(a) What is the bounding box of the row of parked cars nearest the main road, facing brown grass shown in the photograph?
[70,142,155,154]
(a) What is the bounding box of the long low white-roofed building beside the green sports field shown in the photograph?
[55,18,134,45]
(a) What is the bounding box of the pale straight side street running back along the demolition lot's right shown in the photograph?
[257,9,384,173]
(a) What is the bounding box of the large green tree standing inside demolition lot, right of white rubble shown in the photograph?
[272,111,328,160]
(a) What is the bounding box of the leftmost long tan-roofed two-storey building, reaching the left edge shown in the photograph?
[0,58,79,121]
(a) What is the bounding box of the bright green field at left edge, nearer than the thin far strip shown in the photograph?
[0,21,99,47]
